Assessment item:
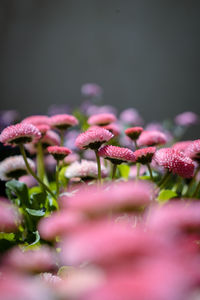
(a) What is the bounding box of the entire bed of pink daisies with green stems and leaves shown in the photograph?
[0,89,200,300]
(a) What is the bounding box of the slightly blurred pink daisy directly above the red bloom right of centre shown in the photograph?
[137,130,167,147]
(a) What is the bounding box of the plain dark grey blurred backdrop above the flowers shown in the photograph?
[0,0,200,121]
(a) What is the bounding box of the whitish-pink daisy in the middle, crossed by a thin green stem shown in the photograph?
[65,160,108,179]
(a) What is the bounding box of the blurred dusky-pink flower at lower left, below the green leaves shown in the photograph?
[3,246,56,272]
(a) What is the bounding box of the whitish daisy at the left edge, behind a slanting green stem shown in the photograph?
[0,155,35,181]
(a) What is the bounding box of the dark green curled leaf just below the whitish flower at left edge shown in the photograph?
[6,179,29,206]
